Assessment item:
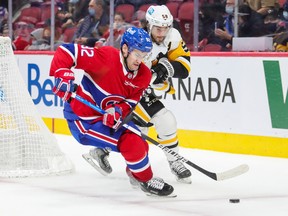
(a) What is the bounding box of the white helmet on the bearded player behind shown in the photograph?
[146,5,173,32]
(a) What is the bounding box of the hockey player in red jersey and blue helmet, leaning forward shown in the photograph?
[50,27,174,196]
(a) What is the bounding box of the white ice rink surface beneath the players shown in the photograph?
[0,135,288,216]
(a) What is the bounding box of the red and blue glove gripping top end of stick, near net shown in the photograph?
[53,69,75,101]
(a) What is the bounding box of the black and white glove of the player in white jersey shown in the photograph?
[151,57,174,84]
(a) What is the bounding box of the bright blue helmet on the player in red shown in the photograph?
[121,26,152,52]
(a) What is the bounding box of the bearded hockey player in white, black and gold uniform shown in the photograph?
[133,5,191,184]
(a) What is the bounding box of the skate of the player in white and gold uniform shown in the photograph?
[169,160,192,184]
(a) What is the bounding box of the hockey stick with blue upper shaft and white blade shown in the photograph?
[71,93,249,181]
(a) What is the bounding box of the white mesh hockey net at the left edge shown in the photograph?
[0,37,74,177]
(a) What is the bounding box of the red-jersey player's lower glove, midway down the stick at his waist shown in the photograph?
[103,105,122,129]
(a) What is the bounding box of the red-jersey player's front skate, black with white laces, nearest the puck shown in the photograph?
[140,177,176,197]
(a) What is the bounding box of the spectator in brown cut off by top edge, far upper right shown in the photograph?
[244,0,279,17]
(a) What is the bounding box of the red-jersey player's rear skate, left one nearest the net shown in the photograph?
[82,148,112,176]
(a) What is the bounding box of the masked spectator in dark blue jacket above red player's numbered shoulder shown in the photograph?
[75,0,109,45]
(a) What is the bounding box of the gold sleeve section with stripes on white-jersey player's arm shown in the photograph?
[168,40,191,73]
